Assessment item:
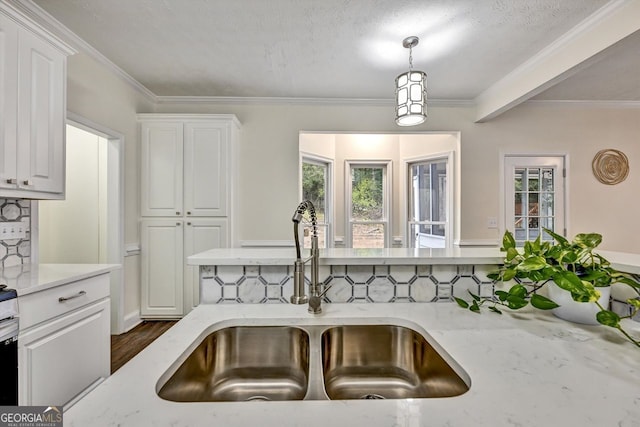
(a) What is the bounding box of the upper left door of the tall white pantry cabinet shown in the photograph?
[140,122,184,216]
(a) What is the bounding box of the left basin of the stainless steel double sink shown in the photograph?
[158,326,309,402]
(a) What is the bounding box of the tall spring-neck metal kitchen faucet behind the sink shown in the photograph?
[291,200,330,314]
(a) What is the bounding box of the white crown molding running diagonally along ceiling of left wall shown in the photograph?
[13,0,157,103]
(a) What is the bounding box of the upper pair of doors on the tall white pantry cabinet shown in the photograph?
[138,114,238,217]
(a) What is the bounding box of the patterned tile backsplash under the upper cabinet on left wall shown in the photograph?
[0,198,31,267]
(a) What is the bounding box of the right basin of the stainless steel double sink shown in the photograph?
[322,325,469,399]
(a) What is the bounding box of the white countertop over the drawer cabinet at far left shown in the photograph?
[0,264,120,296]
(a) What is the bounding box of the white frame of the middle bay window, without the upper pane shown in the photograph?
[344,160,393,248]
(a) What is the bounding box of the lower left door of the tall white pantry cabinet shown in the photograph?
[140,219,184,318]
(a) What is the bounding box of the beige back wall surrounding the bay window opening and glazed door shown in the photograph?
[151,103,640,253]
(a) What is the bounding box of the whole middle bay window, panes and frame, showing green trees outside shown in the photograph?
[346,161,391,248]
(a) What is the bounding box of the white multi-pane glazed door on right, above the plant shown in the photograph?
[505,156,566,245]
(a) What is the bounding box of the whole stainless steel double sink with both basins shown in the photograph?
[157,322,471,402]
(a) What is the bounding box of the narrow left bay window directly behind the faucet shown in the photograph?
[302,157,331,248]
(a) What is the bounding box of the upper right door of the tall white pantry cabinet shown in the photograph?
[184,121,230,216]
